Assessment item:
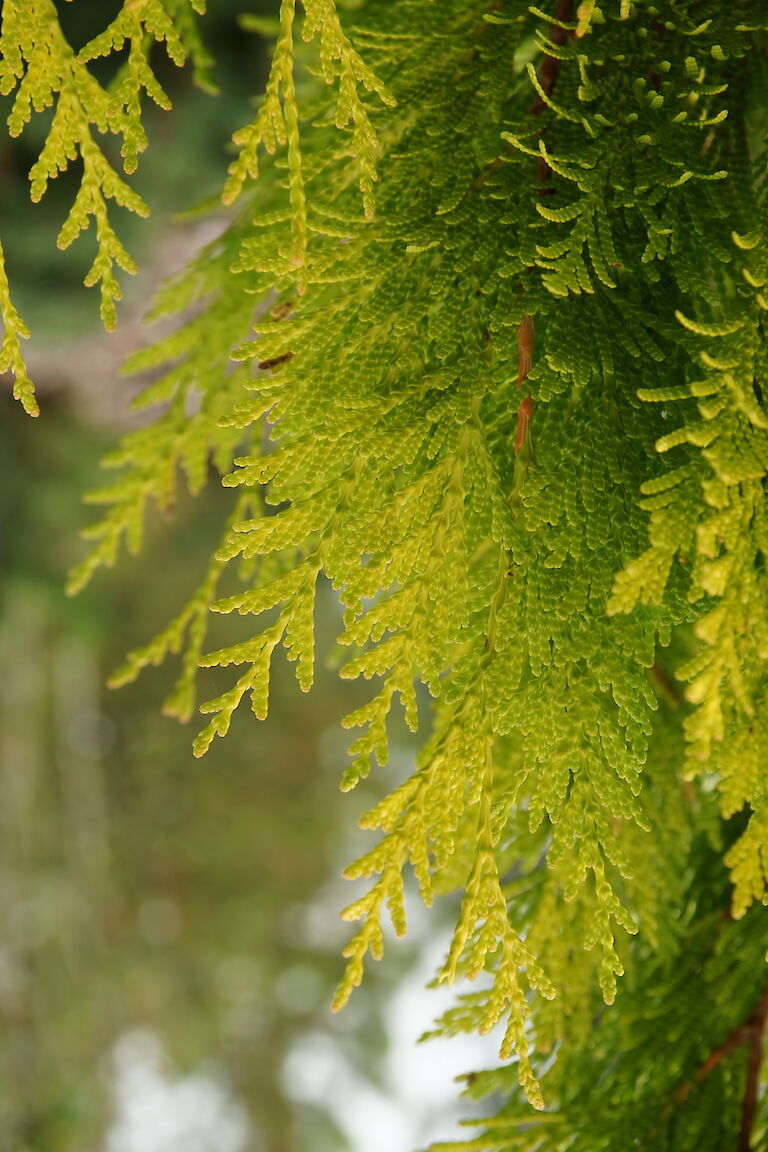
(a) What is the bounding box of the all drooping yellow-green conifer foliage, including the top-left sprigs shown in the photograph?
[0,0,768,1152]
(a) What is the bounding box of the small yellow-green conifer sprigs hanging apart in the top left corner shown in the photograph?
[0,0,206,366]
